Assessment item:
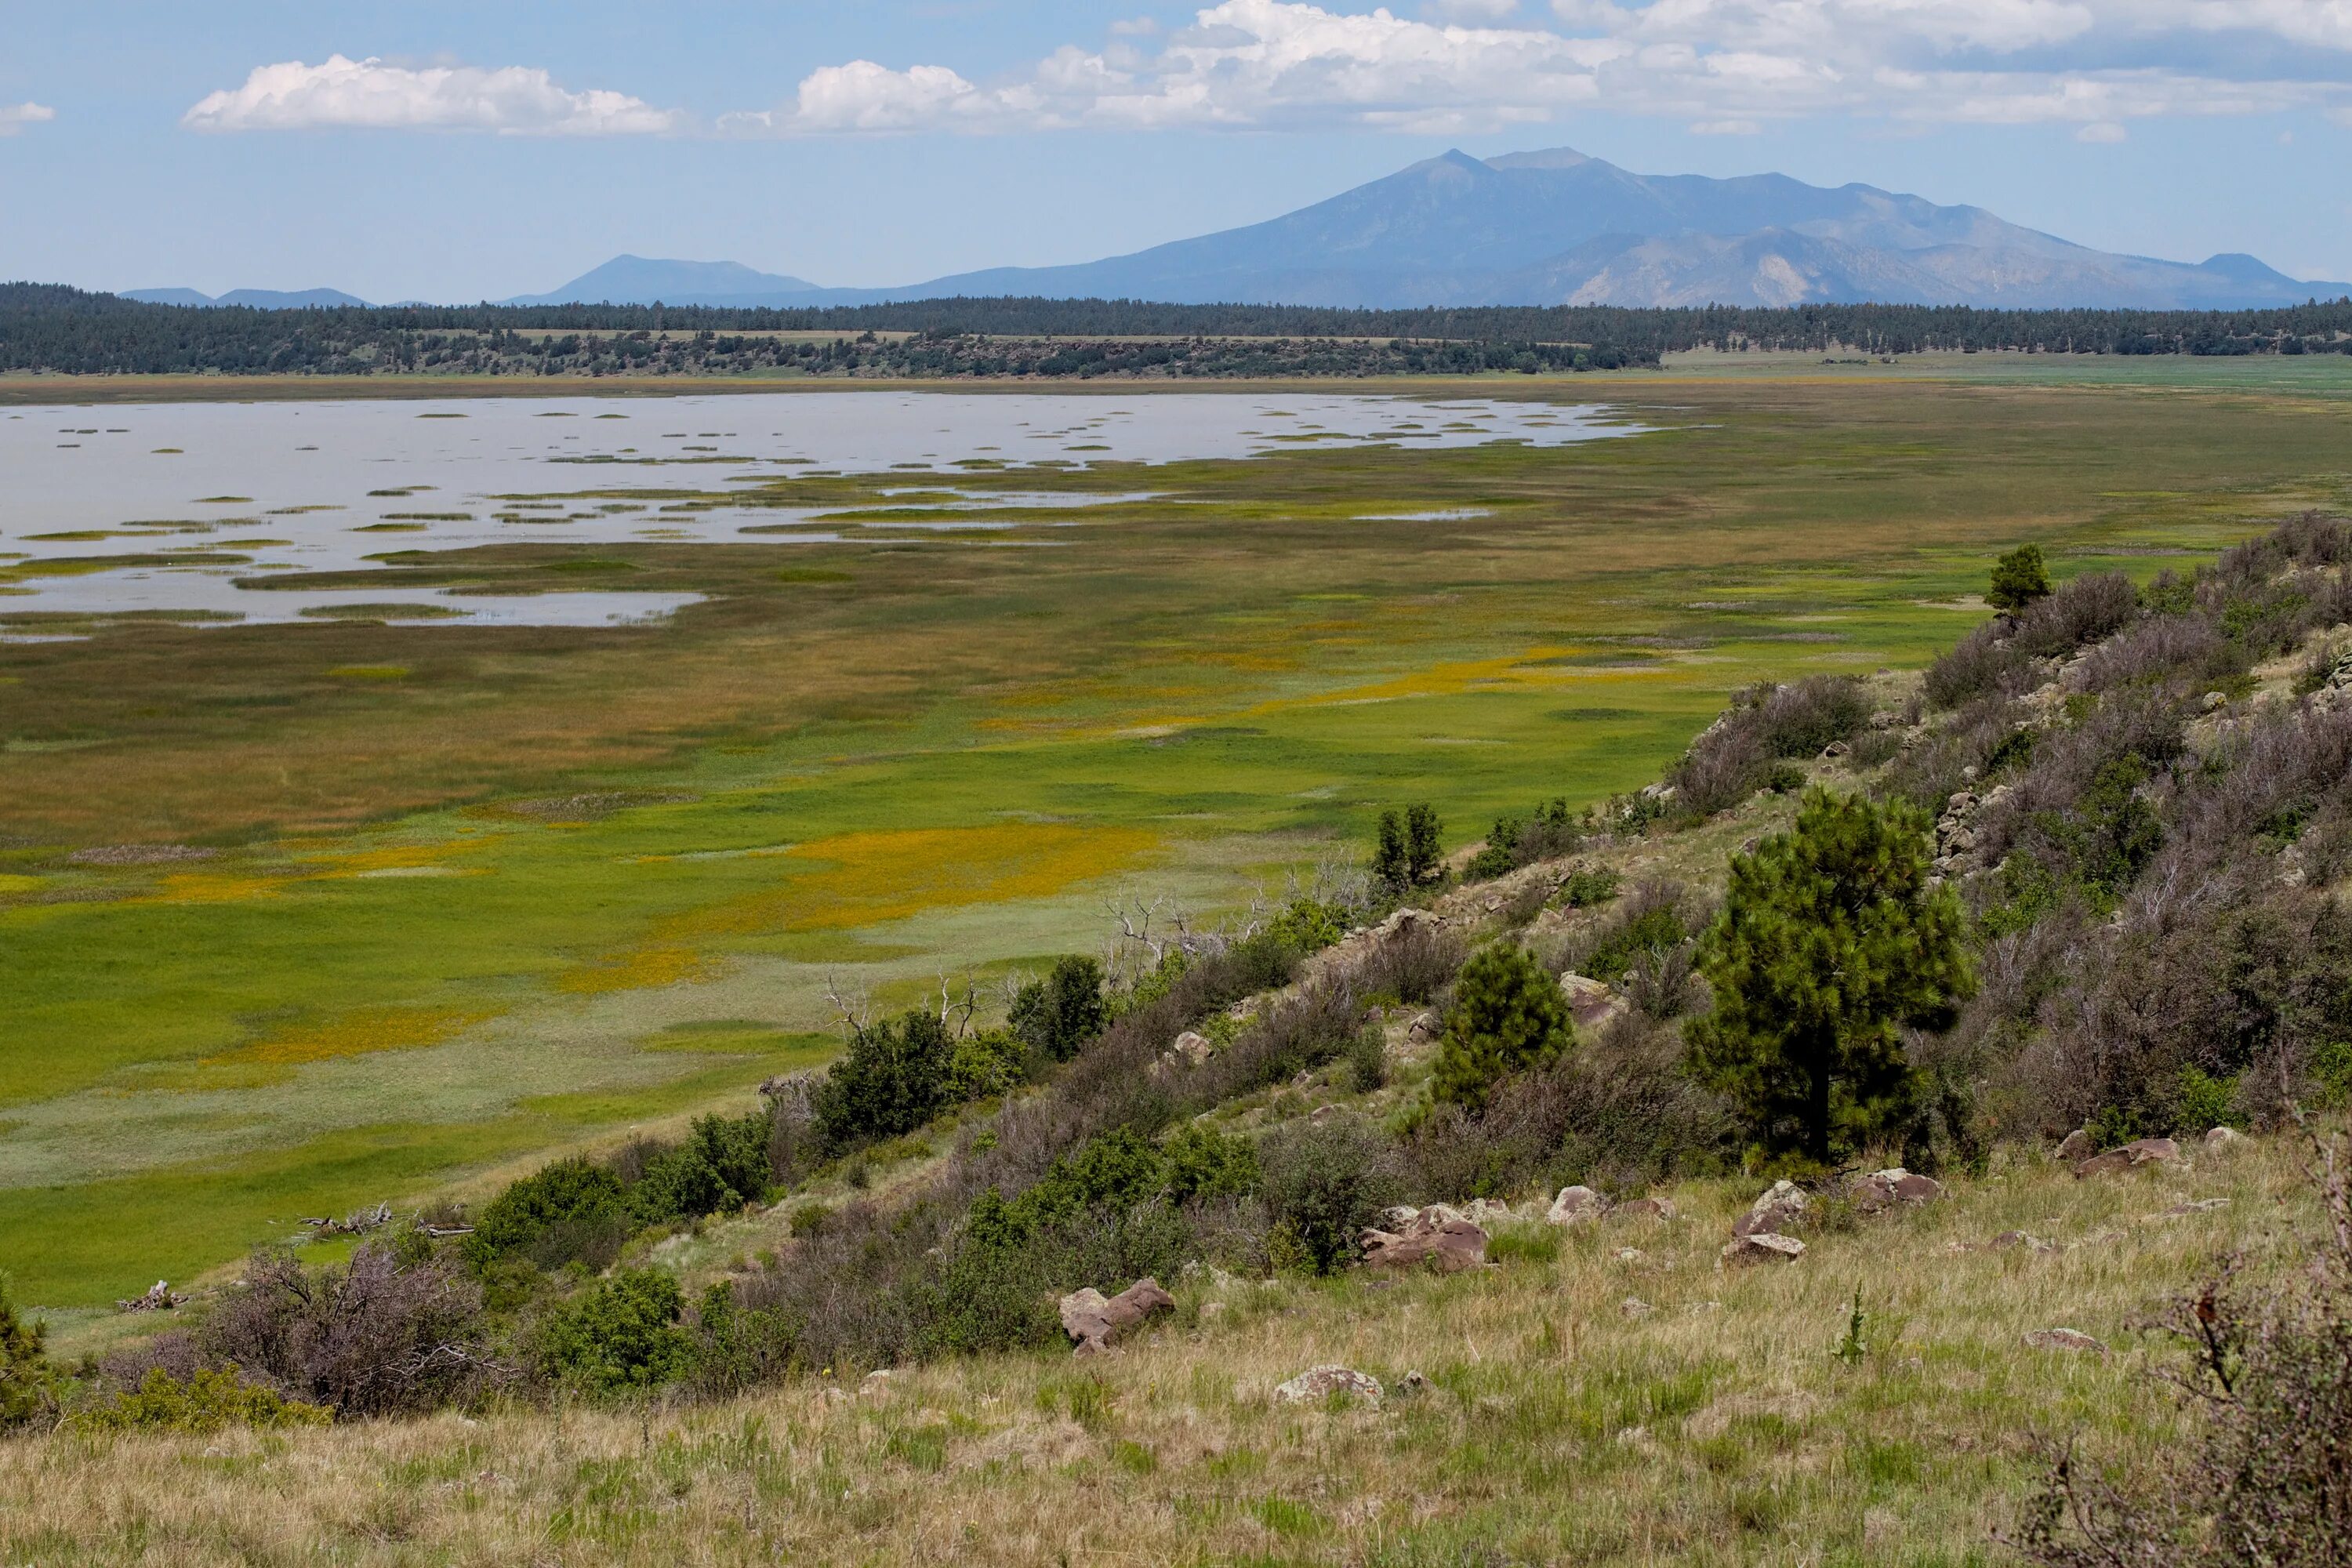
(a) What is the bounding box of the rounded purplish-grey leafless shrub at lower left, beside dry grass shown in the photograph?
[195,1241,503,1415]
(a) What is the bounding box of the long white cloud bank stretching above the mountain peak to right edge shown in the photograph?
[724,0,2352,136]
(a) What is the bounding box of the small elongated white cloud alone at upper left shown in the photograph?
[181,54,684,136]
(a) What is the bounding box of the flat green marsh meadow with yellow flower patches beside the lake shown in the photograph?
[0,368,2352,1309]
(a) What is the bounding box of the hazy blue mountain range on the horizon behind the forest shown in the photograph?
[129,148,2352,310]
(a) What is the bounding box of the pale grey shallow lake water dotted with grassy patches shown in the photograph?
[0,393,1635,637]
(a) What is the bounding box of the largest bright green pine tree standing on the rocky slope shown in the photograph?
[1689,789,1976,1163]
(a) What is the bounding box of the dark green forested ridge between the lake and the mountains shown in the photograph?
[0,282,2352,379]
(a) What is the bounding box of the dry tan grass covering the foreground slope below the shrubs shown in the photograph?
[0,1145,2310,1566]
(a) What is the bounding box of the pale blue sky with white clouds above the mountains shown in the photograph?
[0,0,2352,301]
